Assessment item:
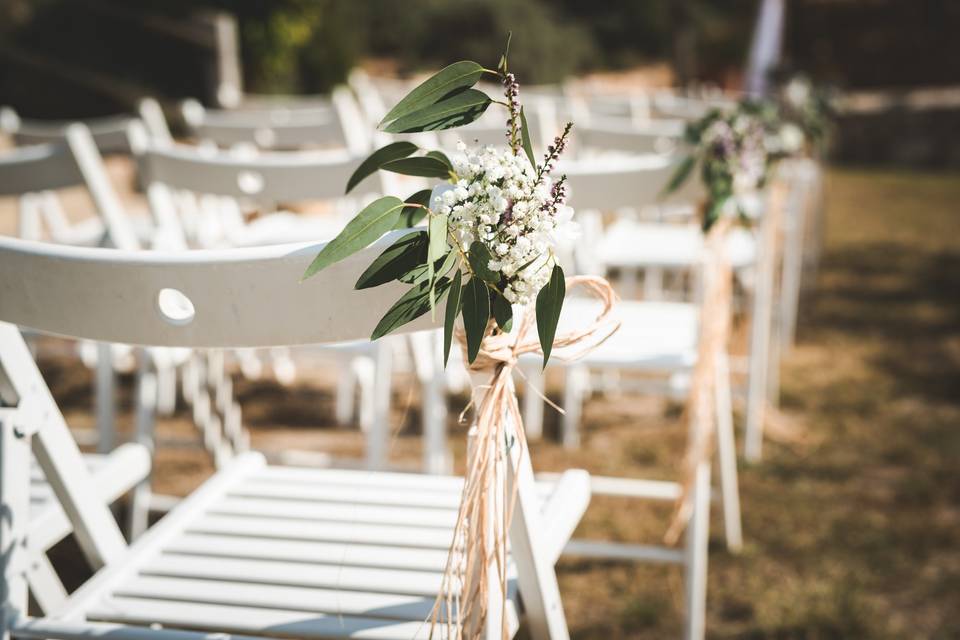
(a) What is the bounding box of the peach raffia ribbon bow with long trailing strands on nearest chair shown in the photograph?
[431,276,620,640]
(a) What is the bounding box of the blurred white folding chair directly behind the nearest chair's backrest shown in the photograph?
[131,128,448,470]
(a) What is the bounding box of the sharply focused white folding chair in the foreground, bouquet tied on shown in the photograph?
[0,234,590,640]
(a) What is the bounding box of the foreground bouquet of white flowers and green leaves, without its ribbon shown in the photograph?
[304,43,573,366]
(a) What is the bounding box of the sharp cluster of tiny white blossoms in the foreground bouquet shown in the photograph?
[431,142,574,304]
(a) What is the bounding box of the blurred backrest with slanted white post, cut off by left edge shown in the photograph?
[0,123,140,250]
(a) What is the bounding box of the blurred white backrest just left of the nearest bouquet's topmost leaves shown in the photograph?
[182,87,370,155]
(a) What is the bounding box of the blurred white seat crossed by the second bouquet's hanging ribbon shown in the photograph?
[597,220,756,269]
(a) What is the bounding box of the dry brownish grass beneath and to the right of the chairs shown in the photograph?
[46,169,960,639]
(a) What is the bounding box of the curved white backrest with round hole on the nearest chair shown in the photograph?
[0,231,428,348]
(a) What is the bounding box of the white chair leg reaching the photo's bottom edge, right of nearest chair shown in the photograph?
[683,462,710,640]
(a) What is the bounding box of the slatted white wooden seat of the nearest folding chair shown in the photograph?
[47,454,589,640]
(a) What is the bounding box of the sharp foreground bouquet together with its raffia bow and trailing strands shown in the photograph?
[304,40,618,638]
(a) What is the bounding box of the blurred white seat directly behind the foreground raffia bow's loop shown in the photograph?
[523,297,699,372]
